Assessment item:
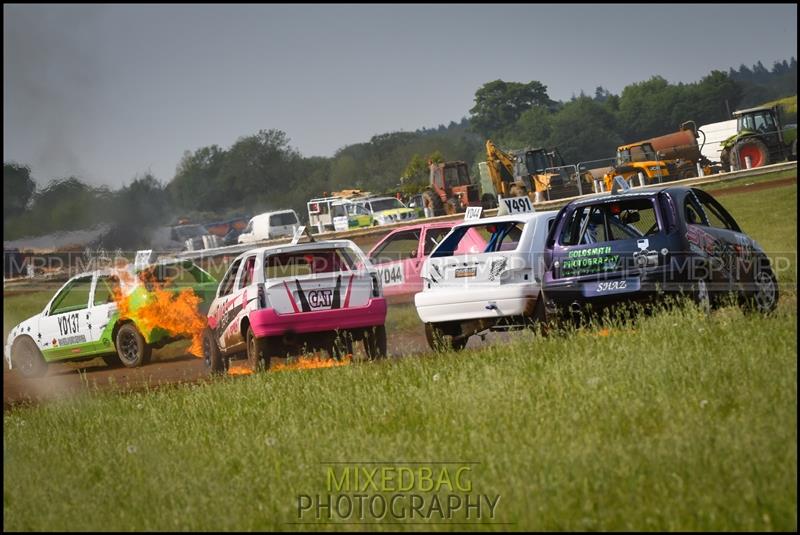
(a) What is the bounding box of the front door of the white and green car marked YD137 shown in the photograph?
[37,275,93,361]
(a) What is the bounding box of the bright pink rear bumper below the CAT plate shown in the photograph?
[249,297,386,338]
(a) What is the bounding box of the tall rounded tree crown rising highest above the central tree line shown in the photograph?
[469,80,553,137]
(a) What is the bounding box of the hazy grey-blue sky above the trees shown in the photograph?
[3,3,797,187]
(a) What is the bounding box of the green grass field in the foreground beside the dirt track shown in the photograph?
[3,173,797,531]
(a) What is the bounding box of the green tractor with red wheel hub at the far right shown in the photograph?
[720,105,797,171]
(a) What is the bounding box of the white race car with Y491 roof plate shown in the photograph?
[414,211,556,350]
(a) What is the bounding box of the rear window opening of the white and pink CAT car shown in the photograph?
[264,247,356,279]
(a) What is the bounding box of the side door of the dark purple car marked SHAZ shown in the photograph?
[693,189,755,290]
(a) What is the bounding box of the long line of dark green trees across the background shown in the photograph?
[3,57,797,248]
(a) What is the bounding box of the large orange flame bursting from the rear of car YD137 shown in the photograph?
[114,270,207,357]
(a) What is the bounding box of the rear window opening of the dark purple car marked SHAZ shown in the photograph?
[559,198,659,245]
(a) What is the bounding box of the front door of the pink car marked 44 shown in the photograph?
[370,229,422,295]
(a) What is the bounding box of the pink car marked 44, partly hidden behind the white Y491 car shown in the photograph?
[367,221,486,297]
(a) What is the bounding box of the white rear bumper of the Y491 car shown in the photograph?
[414,284,539,323]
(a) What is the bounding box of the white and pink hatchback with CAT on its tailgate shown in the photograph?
[203,240,386,373]
